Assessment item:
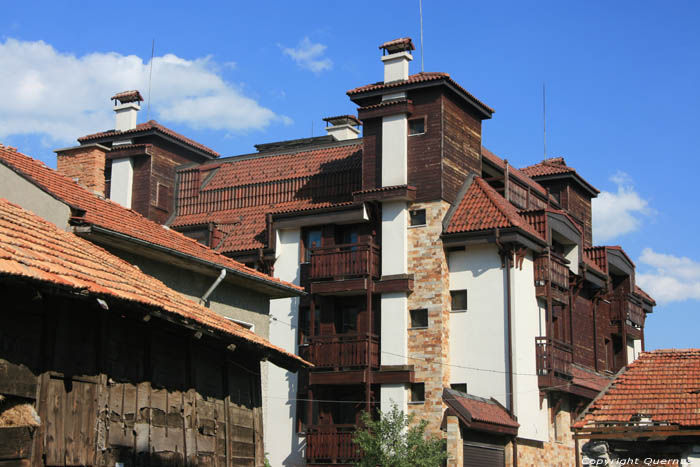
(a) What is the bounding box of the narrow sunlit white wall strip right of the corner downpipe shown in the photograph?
[511,252,549,441]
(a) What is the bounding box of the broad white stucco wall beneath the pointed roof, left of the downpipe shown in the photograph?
[448,245,508,406]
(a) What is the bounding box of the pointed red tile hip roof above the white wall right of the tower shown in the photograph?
[445,177,541,238]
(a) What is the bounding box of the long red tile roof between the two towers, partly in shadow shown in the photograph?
[171,141,362,252]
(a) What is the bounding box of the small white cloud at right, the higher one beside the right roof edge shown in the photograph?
[593,172,654,243]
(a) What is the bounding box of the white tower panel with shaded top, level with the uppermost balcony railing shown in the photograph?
[382,201,408,276]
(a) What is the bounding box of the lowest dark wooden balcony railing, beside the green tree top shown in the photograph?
[306,425,361,463]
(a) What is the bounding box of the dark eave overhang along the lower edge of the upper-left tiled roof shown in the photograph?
[73,224,305,298]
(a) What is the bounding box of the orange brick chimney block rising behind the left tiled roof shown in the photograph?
[54,144,109,197]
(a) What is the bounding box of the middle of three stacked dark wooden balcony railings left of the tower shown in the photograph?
[300,334,379,369]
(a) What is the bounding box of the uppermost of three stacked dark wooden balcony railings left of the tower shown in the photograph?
[310,243,381,280]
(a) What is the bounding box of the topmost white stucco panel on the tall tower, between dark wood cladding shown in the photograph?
[382,114,408,186]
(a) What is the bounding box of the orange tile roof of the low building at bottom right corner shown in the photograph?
[574,349,700,429]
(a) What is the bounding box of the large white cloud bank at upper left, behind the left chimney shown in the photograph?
[0,39,289,144]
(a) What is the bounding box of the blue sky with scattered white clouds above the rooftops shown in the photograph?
[0,0,700,349]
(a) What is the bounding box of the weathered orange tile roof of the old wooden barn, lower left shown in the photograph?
[0,199,309,368]
